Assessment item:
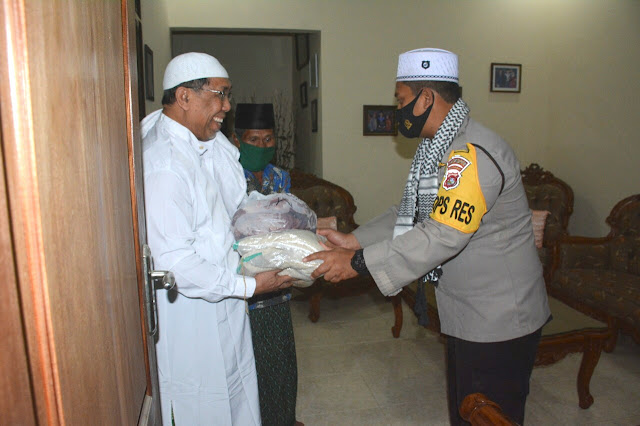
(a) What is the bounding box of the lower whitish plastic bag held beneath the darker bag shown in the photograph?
[233,229,326,287]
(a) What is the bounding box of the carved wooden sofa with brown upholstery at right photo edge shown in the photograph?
[547,194,640,351]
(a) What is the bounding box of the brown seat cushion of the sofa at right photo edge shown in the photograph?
[550,269,640,329]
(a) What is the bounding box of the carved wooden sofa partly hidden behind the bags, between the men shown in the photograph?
[290,169,402,337]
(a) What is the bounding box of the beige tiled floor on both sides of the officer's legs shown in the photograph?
[291,290,640,426]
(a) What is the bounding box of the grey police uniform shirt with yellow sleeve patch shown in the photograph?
[353,118,550,342]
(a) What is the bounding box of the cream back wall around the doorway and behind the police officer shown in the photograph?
[143,0,640,235]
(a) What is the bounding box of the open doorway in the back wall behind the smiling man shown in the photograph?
[171,28,322,176]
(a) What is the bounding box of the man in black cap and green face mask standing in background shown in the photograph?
[233,103,302,426]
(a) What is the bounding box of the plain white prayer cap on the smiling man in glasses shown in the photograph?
[162,52,229,90]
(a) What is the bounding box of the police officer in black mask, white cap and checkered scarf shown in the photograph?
[306,49,550,425]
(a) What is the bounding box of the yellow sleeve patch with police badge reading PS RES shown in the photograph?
[431,144,487,233]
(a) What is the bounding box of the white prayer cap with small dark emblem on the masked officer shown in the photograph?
[396,48,458,83]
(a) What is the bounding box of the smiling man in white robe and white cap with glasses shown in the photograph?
[142,52,291,426]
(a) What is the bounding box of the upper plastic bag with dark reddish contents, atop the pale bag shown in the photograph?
[231,191,318,241]
